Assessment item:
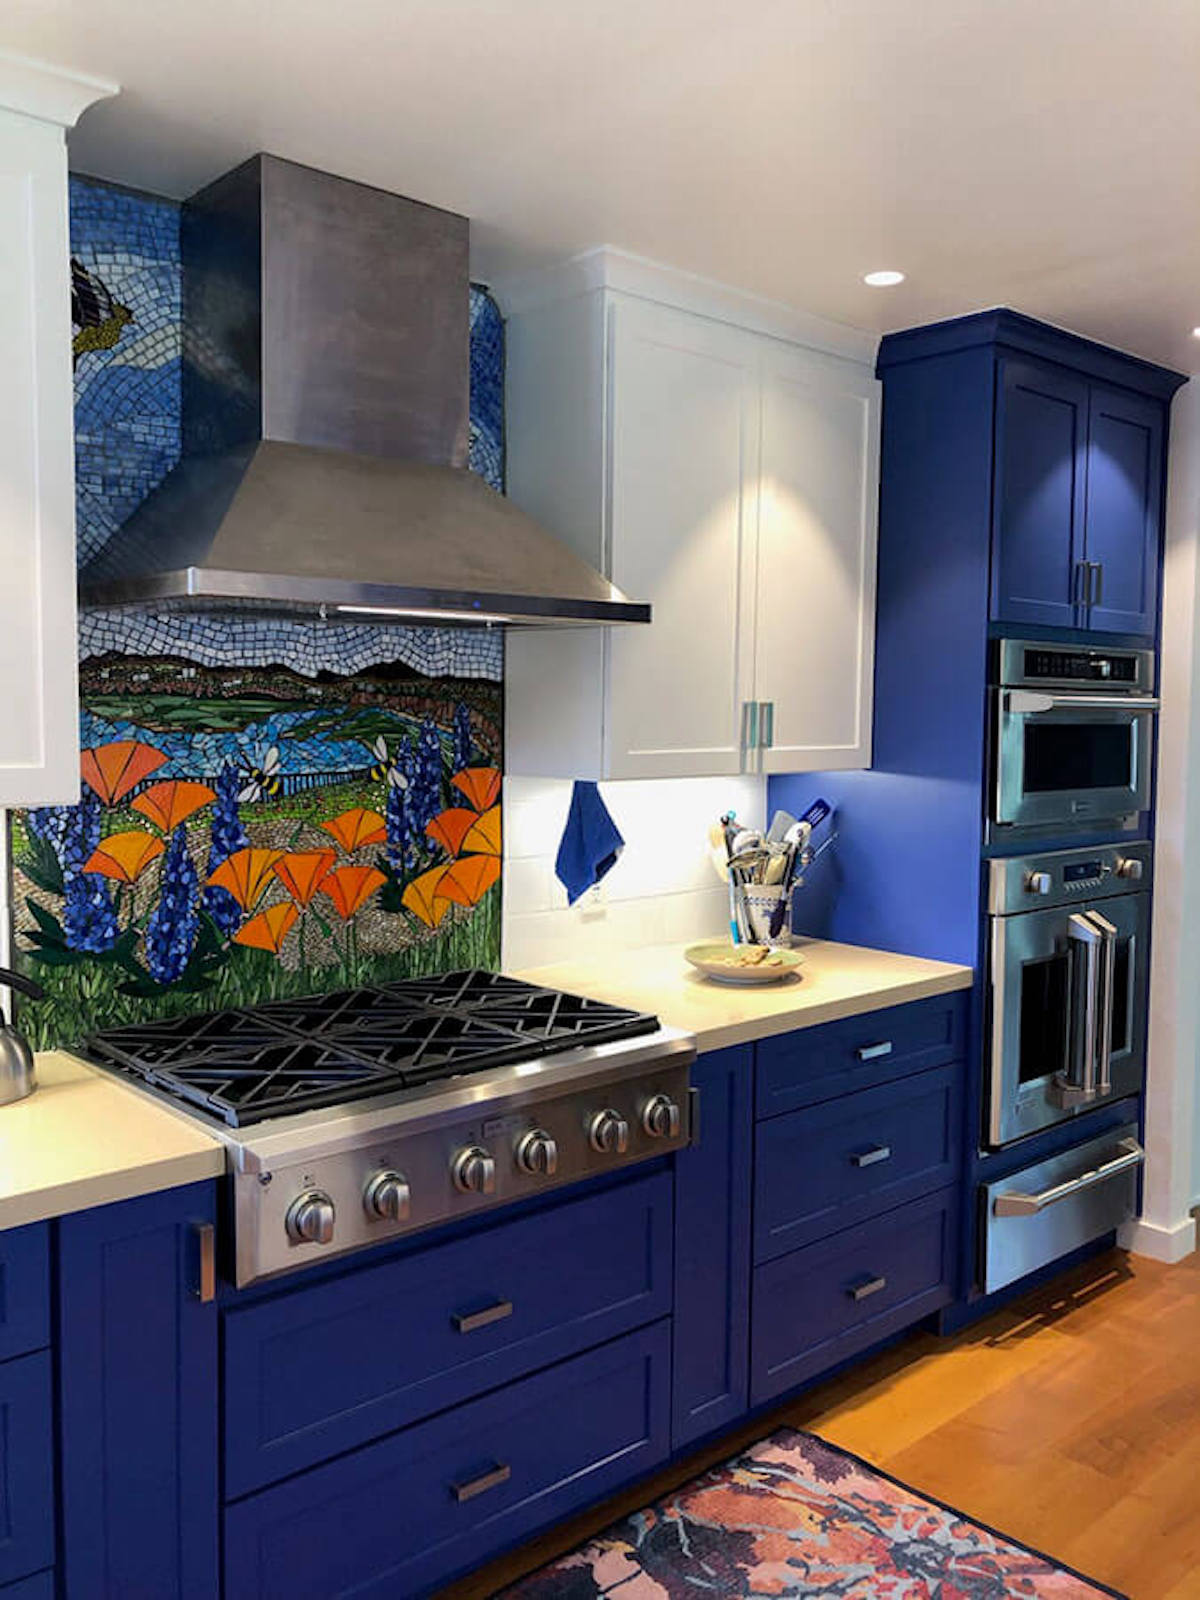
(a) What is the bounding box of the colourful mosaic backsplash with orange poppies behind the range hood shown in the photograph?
[11,178,504,1046]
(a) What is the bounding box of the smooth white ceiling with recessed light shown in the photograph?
[9,0,1200,371]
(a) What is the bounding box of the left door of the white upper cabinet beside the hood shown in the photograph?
[605,301,757,778]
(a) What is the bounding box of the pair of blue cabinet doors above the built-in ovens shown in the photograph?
[992,355,1165,637]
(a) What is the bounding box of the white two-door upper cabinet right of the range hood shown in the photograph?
[506,253,878,778]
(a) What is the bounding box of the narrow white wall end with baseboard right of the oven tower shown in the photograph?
[1122,378,1200,1261]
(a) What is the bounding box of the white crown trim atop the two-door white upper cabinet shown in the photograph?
[490,245,878,363]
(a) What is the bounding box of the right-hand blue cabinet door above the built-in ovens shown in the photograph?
[1086,387,1163,634]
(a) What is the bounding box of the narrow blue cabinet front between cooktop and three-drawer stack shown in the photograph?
[670,1045,754,1450]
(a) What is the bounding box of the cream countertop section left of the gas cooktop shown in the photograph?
[0,1050,226,1229]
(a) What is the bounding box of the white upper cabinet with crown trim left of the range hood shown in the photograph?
[0,54,115,806]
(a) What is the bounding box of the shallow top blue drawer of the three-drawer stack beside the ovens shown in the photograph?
[755,990,966,1118]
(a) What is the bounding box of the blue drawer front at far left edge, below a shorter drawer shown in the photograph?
[0,1350,54,1584]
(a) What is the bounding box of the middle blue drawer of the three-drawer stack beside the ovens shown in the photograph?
[754,1062,963,1262]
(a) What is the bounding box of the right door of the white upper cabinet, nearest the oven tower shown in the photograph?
[754,341,880,773]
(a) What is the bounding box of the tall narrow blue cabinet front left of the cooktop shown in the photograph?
[59,1182,219,1600]
